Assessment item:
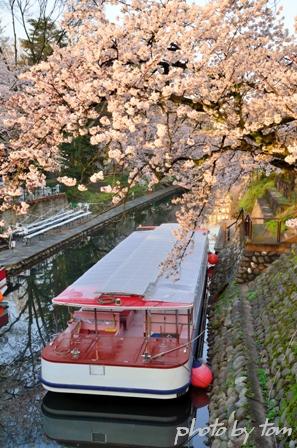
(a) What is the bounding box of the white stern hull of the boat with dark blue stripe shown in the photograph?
[41,359,191,399]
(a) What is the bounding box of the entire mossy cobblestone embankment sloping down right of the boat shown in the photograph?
[209,253,297,448]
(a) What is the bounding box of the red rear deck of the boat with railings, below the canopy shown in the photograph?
[42,311,190,368]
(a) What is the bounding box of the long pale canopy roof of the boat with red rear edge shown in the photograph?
[53,224,208,310]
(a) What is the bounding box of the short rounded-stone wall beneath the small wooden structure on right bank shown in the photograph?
[236,248,280,283]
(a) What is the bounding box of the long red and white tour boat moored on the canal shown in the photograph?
[41,224,208,399]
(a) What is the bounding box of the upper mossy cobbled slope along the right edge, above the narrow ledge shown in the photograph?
[248,249,297,448]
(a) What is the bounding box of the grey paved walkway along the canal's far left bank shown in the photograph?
[0,187,182,273]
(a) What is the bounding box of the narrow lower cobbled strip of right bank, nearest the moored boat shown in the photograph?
[209,285,252,448]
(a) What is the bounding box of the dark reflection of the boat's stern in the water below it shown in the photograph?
[42,391,208,448]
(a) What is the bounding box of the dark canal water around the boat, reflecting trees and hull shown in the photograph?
[0,199,208,448]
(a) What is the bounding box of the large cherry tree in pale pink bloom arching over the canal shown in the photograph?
[1,0,297,236]
